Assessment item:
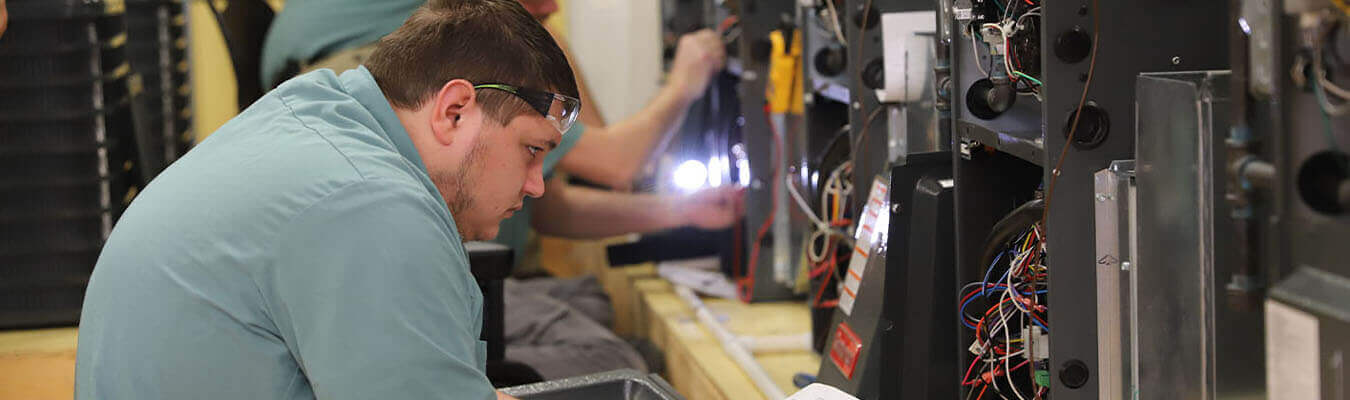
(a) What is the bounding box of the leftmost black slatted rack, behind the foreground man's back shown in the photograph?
[0,1,138,328]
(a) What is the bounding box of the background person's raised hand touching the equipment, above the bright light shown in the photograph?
[668,30,726,101]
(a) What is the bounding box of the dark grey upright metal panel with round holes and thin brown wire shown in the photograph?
[1041,1,1229,399]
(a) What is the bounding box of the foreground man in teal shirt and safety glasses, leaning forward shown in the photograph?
[76,0,569,399]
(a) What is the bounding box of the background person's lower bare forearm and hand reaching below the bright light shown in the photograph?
[531,178,744,239]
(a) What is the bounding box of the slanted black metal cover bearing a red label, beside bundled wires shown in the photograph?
[819,151,956,399]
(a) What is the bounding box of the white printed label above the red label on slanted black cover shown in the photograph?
[840,177,891,315]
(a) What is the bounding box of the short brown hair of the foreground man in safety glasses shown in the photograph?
[365,0,579,124]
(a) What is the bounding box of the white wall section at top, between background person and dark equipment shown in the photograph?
[566,0,662,123]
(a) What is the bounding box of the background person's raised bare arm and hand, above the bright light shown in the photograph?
[559,30,726,189]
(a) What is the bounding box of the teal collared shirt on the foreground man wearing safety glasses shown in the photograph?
[76,68,494,400]
